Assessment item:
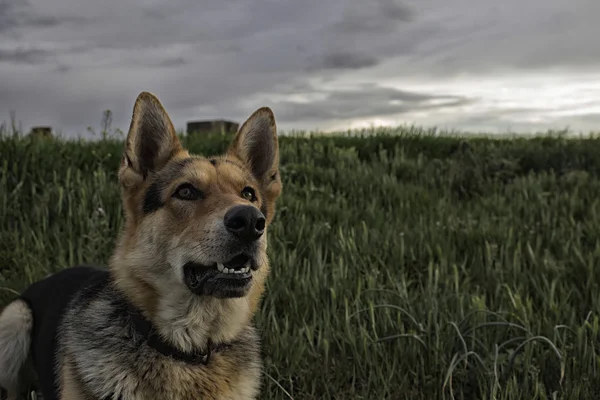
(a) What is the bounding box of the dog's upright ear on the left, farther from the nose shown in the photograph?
[119,92,183,187]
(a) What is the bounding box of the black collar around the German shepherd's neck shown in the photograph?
[127,303,230,365]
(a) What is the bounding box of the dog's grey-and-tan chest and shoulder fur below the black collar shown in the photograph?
[58,270,262,400]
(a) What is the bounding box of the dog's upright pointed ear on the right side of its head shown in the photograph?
[227,107,279,185]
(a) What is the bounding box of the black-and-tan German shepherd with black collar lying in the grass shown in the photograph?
[0,92,282,400]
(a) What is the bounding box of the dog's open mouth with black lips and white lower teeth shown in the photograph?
[183,254,257,297]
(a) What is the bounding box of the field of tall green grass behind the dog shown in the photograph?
[0,129,600,399]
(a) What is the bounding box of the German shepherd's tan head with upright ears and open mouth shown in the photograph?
[116,92,281,299]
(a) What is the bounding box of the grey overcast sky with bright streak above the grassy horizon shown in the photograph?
[0,0,600,136]
